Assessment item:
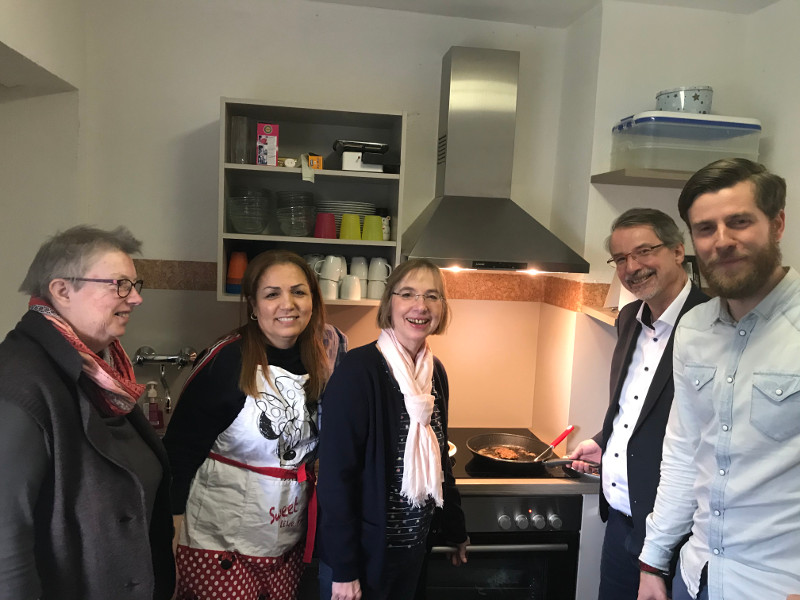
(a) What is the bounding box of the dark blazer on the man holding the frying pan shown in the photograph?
[595,285,708,553]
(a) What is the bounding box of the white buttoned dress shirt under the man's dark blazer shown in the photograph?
[602,278,692,516]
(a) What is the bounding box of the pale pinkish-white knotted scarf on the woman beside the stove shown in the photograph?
[378,329,444,506]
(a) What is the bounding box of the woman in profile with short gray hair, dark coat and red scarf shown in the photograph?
[0,226,175,600]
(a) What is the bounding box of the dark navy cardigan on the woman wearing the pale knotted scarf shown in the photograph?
[317,342,467,587]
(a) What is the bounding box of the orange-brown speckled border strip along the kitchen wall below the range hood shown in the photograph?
[139,258,609,312]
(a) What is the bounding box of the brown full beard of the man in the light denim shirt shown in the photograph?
[697,230,781,300]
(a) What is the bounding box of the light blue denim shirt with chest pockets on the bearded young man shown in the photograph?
[640,269,800,600]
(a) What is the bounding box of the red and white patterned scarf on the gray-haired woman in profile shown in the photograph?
[28,297,145,416]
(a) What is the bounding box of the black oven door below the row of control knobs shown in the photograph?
[425,531,579,600]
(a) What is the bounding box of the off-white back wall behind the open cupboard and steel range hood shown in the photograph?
[76,0,564,260]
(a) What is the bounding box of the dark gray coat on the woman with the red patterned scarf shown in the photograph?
[0,312,175,600]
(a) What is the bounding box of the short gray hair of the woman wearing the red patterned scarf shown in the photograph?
[19,225,142,301]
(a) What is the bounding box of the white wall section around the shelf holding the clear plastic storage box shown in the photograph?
[584,0,759,281]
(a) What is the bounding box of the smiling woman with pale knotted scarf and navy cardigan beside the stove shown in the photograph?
[318,259,469,600]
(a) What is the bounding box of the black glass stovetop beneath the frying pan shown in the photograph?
[447,427,580,480]
